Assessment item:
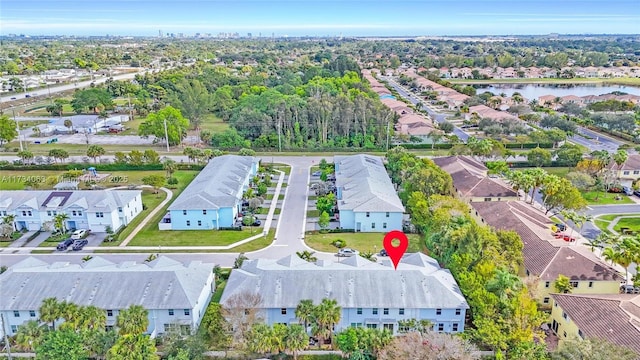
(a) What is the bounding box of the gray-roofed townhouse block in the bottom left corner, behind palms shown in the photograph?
[0,256,215,337]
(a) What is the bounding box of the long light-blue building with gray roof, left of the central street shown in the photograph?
[158,155,258,230]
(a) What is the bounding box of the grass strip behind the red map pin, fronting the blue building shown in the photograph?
[304,233,420,252]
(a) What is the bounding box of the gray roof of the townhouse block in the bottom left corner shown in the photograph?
[0,256,214,310]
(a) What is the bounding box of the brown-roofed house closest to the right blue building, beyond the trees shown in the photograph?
[432,156,518,202]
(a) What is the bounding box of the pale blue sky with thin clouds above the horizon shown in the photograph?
[0,0,640,36]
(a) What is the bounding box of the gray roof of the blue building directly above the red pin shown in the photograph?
[334,154,404,212]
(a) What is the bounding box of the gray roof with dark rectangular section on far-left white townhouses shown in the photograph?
[0,190,142,211]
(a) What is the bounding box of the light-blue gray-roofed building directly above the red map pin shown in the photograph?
[334,154,404,232]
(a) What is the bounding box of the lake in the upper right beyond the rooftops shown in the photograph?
[474,84,640,100]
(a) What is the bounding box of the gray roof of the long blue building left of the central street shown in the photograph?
[169,155,258,210]
